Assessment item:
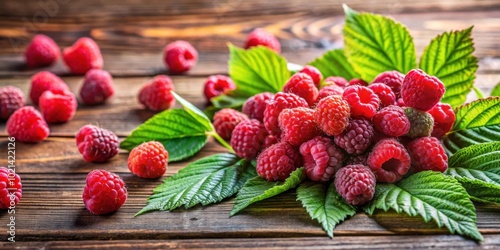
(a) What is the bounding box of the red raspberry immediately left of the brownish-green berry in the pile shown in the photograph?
[372,105,410,137]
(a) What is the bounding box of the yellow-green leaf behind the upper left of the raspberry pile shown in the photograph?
[229,44,290,97]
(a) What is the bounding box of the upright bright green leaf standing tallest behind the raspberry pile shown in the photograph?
[343,4,416,82]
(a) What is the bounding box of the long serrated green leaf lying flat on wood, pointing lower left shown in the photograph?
[137,153,256,215]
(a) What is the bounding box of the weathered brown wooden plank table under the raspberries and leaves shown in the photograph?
[0,0,500,249]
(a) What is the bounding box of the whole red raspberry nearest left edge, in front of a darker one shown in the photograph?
[6,107,50,142]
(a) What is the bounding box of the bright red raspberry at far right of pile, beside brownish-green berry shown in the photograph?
[429,103,456,138]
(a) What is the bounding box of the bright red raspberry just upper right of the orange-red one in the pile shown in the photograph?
[342,86,380,119]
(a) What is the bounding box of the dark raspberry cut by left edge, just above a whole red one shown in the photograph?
[0,86,25,120]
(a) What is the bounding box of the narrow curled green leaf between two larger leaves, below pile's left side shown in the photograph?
[231,168,305,216]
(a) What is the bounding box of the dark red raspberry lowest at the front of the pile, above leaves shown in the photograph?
[334,165,376,205]
